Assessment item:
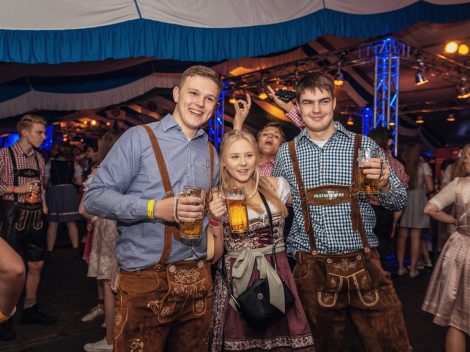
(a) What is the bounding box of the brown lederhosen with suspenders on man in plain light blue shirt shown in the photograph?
[114,125,214,352]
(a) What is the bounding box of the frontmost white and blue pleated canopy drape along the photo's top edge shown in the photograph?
[0,0,470,64]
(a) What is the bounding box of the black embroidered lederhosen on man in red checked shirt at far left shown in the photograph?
[0,147,46,261]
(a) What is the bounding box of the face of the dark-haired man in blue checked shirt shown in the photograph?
[298,88,336,140]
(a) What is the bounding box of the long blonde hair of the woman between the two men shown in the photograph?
[220,130,287,217]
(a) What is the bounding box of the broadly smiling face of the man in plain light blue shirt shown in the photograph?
[173,75,219,139]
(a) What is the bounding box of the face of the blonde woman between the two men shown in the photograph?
[223,138,258,186]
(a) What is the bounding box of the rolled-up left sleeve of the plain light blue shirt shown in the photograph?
[84,128,148,222]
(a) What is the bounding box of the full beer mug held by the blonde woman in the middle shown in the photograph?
[225,187,249,235]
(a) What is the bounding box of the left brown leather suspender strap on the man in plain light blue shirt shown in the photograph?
[142,125,179,264]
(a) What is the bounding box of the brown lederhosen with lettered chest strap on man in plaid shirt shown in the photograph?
[288,134,410,352]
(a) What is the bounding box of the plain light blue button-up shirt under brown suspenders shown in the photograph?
[84,115,218,270]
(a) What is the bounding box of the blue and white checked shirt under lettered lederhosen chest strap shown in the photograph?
[273,122,407,254]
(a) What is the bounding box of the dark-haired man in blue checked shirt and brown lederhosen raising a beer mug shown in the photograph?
[273,73,410,352]
